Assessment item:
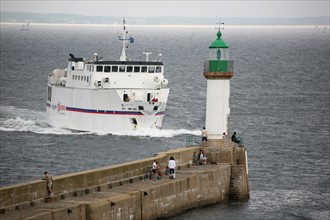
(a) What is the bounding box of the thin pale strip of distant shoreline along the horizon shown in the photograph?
[0,22,330,29]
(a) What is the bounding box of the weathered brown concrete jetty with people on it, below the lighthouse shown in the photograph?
[0,140,249,220]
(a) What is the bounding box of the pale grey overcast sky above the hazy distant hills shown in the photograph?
[1,0,330,18]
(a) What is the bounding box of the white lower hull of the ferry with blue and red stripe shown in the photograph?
[47,86,169,133]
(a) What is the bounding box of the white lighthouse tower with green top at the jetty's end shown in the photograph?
[204,28,234,140]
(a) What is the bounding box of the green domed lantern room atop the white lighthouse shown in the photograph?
[209,30,231,72]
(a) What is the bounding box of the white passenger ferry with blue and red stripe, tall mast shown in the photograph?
[46,19,170,133]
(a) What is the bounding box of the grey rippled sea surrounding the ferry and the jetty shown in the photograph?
[0,22,330,220]
